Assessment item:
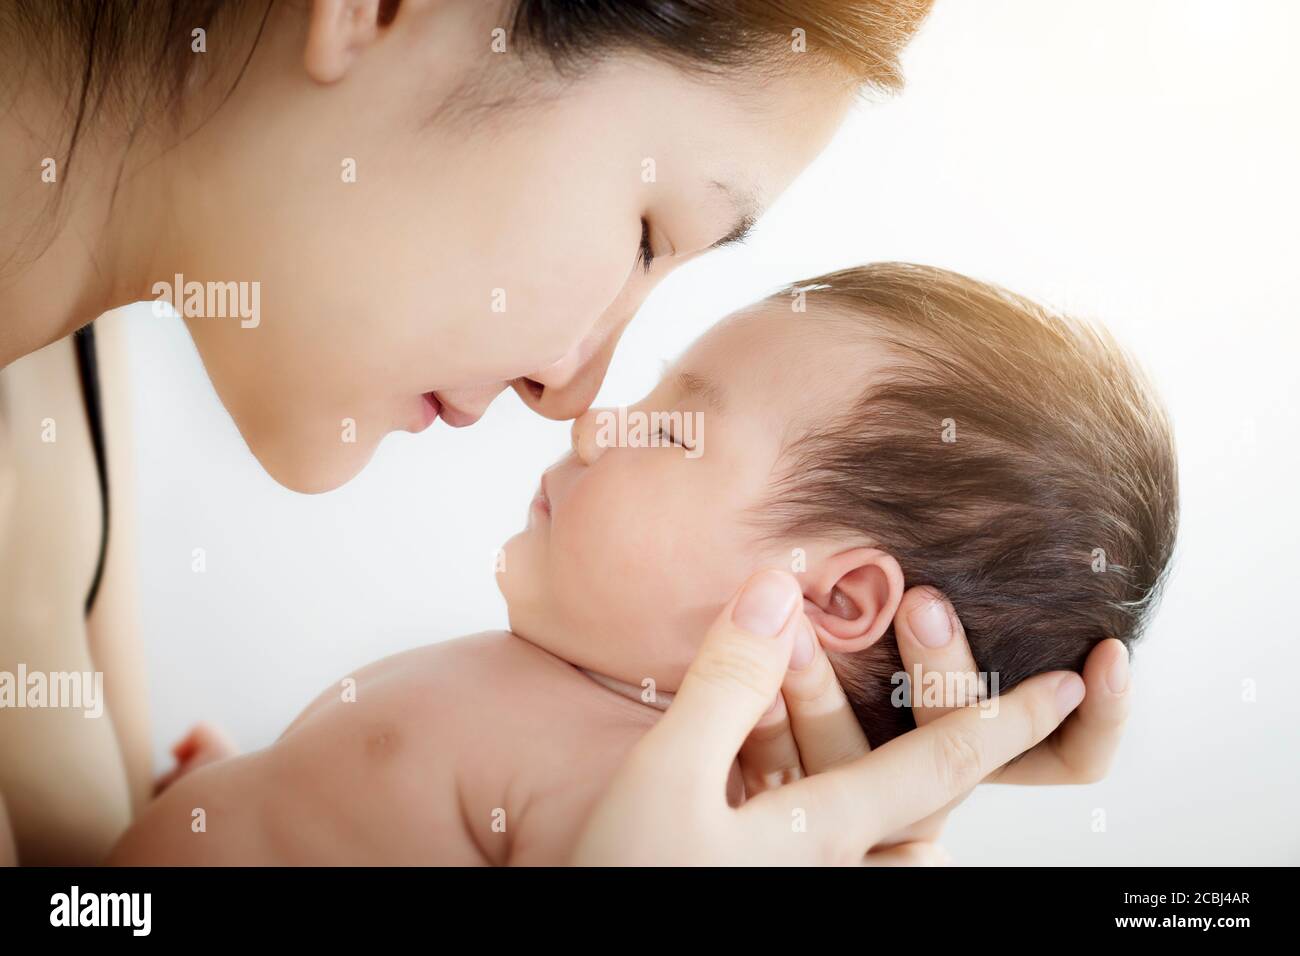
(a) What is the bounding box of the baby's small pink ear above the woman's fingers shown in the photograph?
[803,548,904,654]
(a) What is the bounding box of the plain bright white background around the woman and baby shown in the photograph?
[114,0,1300,864]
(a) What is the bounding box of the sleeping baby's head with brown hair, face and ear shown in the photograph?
[498,264,1178,744]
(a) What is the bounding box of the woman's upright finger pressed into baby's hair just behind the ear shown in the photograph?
[894,587,980,727]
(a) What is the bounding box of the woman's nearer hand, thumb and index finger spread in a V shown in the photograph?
[573,571,1083,865]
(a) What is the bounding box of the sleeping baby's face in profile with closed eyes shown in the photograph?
[498,299,894,691]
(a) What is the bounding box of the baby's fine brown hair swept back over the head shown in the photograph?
[758,263,1178,747]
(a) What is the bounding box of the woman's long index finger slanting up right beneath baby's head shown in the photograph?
[754,671,1084,862]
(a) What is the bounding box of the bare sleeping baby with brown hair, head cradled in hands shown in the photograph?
[113,264,1178,864]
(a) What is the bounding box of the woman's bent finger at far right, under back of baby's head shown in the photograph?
[992,637,1132,784]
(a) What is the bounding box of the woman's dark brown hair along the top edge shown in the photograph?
[0,0,932,192]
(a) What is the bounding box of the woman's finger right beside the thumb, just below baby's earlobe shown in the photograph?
[781,615,871,774]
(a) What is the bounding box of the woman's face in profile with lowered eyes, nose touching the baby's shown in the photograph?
[162,3,853,492]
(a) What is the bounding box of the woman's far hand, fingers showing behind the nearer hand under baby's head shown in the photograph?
[741,588,1128,842]
